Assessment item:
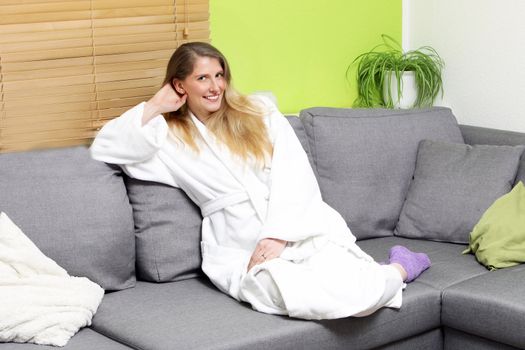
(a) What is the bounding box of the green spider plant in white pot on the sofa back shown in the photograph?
[347,34,444,108]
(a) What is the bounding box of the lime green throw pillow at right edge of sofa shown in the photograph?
[463,181,525,270]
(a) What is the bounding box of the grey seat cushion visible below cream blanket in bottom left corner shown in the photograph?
[0,328,131,350]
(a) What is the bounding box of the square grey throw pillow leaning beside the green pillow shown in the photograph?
[395,140,524,243]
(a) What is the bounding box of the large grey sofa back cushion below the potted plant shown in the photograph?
[300,107,463,239]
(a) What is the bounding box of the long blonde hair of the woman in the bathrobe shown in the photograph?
[162,42,272,163]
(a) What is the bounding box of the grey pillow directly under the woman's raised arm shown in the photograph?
[125,176,202,282]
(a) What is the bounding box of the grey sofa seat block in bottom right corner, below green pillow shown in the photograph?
[442,265,525,349]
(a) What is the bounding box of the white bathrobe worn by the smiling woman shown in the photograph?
[91,96,403,319]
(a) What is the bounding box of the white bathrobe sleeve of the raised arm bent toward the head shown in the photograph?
[90,102,178,187]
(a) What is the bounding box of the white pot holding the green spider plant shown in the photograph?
[383,71,417,108]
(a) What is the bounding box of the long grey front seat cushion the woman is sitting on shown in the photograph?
[93,278,440,350]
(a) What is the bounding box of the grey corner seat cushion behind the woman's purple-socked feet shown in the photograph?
[357,237,488,291]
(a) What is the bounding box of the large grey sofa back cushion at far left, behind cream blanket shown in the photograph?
[0,147,135,290]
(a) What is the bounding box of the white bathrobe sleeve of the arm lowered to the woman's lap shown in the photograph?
[259,95,353,246]
